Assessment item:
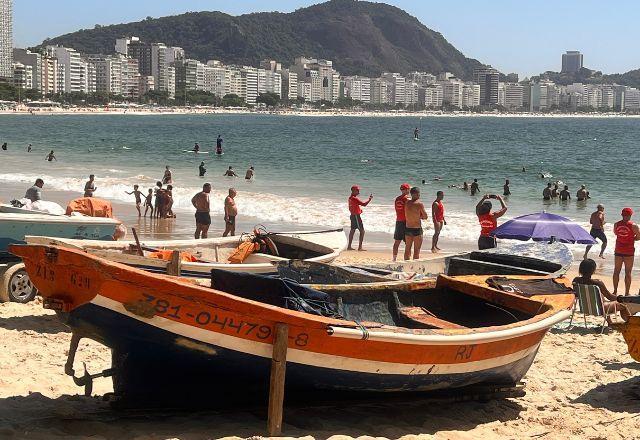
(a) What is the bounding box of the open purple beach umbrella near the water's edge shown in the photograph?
[491,211,596,244]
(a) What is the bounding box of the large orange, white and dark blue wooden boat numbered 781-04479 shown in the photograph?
[11,245,574,402]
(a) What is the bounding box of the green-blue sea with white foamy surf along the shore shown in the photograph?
[0,114,640,253]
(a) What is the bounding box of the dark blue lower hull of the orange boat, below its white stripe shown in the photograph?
[63,303,537,404]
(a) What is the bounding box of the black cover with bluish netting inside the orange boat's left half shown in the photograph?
[211,269,339,318]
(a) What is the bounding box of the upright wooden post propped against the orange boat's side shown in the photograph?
[267,323,289,436]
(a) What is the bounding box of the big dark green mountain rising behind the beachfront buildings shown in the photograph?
[42,0,481,79]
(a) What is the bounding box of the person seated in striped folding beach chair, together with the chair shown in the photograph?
[569,258,629,330]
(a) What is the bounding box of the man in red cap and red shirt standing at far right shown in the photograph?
[613,208,640,295]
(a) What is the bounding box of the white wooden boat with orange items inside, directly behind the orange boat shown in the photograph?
[27,229,347,278]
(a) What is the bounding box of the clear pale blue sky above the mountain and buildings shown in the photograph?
[14,0,640,77]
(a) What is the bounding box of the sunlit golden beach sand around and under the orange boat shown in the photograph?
[0,252,640,439]
